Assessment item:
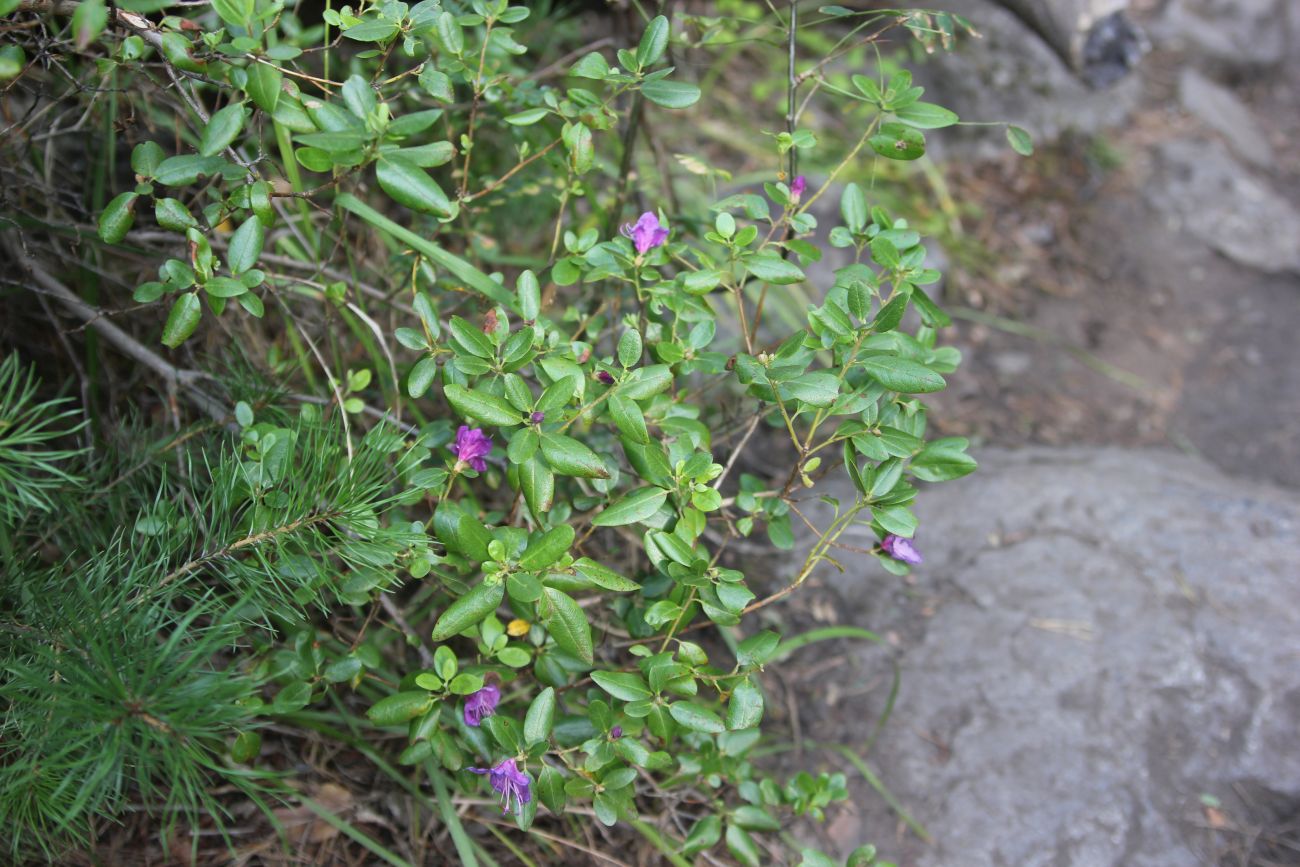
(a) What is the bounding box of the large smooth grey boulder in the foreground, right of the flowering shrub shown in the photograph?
[814,448,1300,867]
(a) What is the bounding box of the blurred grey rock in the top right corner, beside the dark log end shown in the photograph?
[1151,0,1295,75]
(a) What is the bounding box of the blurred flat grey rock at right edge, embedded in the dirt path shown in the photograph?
[1147,139,1300,273]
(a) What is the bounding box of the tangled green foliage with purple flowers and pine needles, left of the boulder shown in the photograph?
[0,0,1003,866]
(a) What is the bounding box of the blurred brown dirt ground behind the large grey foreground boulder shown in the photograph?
[932,42,1300,486]
